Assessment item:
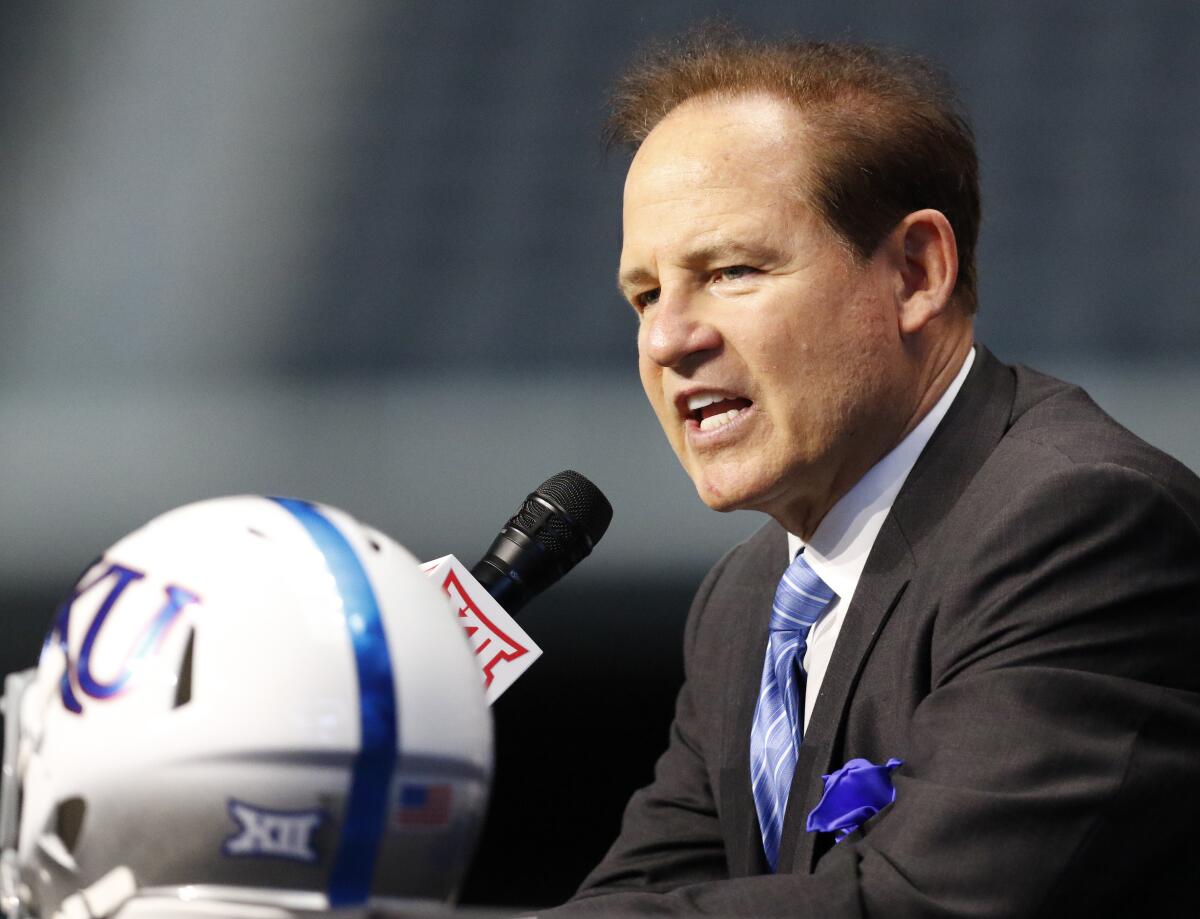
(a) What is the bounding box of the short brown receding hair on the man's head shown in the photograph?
[605,24,979,312]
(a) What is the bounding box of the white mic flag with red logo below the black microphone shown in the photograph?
[421,555,541,705]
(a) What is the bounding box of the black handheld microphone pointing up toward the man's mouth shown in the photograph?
[470,469,612,615]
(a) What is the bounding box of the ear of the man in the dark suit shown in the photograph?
[892,208,959,335]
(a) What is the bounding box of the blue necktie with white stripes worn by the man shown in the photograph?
[750,549,836,871]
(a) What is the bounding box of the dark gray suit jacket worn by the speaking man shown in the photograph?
[556,348,1200,917]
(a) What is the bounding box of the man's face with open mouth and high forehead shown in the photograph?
[620,95,908,533]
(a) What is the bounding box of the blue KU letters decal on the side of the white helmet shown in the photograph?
[43,561,199,714]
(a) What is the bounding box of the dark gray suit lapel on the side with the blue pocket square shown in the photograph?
[772,344,1015,872]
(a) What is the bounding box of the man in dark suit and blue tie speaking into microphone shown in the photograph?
[547,25,1200,917]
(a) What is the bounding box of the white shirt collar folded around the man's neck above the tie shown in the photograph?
[787,348,974,603]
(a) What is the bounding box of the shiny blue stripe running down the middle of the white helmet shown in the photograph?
[271,498,398,907]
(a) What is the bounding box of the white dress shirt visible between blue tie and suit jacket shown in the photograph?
[787,348,974,728]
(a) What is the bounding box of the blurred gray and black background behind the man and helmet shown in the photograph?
[0,0,1200,905]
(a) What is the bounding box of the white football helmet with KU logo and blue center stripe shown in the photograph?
[0,497,492,919]
